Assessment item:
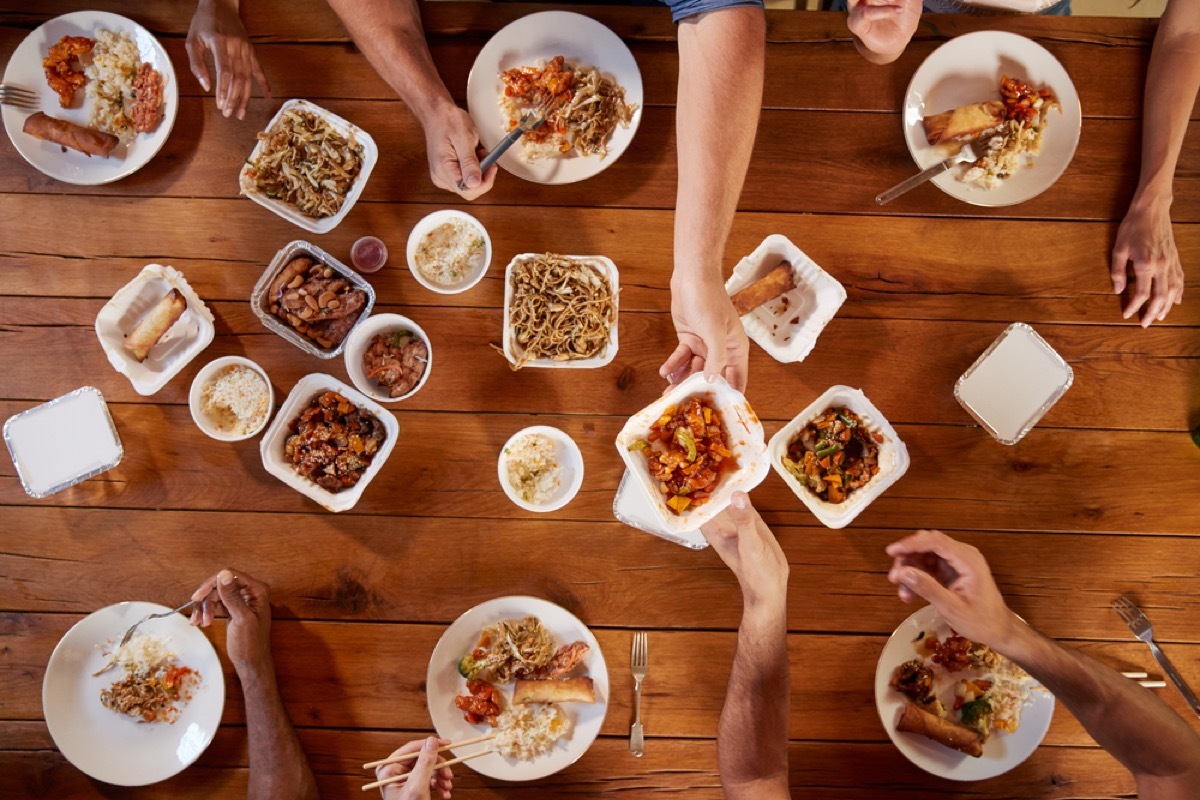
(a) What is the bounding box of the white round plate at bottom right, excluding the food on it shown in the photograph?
[875,606,1054,781]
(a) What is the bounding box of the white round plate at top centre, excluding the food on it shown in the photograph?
[467,11,644,184]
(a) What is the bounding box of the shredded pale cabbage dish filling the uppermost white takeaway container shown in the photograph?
[242,108,362,218]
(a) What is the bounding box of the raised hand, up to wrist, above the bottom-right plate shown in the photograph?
[887,530,1018,651]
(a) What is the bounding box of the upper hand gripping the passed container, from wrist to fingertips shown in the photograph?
[659,277,750,392]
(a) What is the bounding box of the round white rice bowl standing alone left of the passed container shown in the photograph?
[497,425,583,512]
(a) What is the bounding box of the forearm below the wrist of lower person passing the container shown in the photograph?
[716,599,791,800]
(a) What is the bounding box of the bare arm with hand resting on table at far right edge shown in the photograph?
[1109,0,1200,327]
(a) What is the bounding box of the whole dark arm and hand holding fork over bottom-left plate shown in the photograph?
[192,570,318,800]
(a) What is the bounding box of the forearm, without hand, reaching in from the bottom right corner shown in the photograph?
[997,624,1200,786]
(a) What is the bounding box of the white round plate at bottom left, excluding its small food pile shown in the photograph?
[42,602,224,786]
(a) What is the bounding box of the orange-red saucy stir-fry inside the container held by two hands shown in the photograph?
[629,397,738,515]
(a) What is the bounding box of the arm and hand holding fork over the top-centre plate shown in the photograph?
[329,0,498,200]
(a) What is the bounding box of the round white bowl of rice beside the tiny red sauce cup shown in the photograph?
[407,209,492,294]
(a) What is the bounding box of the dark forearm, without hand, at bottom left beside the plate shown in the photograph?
[238,660,318,800]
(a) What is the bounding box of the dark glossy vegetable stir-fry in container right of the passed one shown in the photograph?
[782,408,884,503]
